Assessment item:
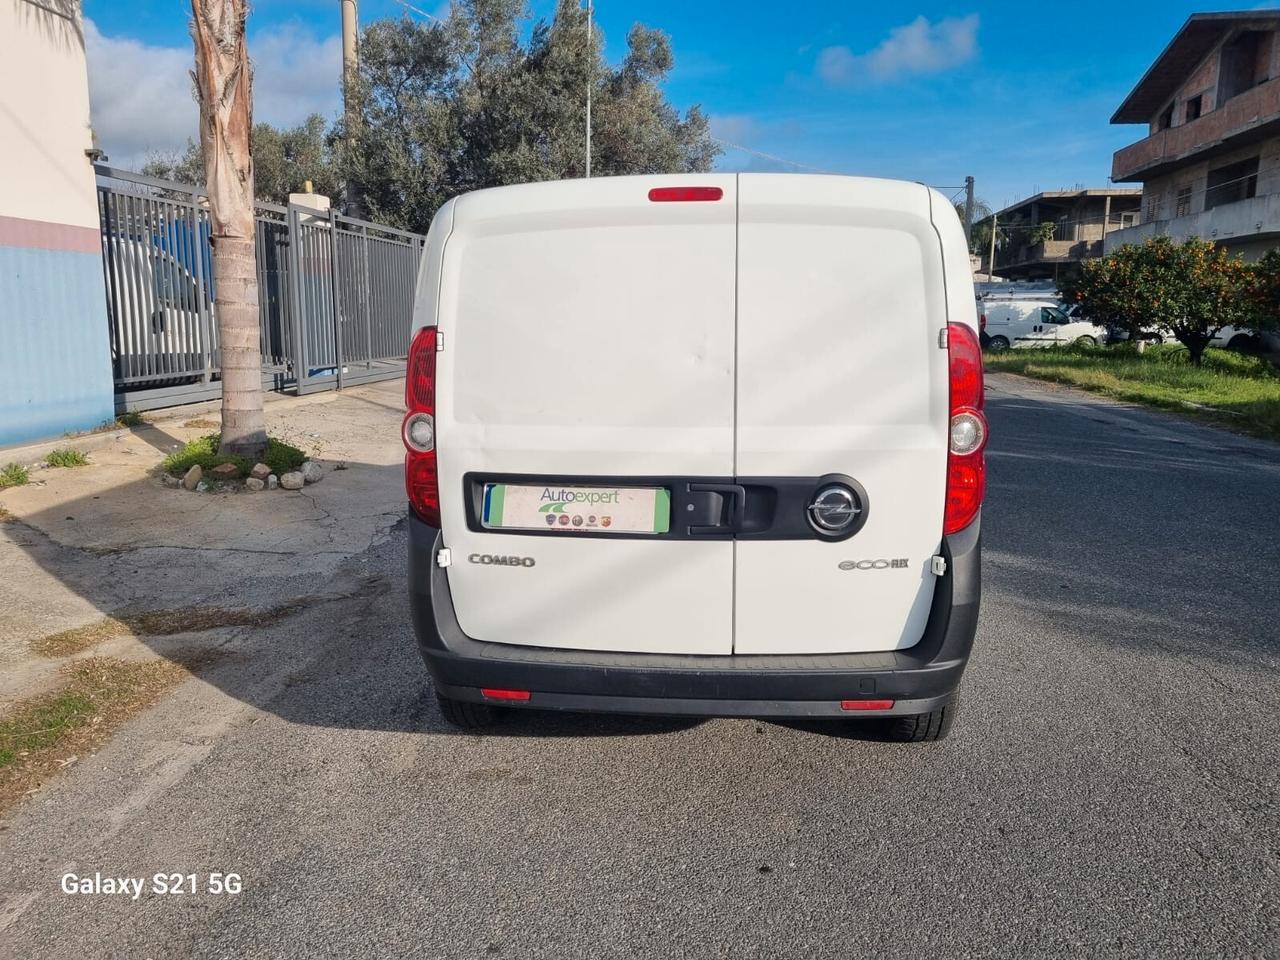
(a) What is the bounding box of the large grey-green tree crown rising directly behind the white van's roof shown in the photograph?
[334,0,718,230]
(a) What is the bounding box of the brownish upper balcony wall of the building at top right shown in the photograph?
[1108,79,1280,181]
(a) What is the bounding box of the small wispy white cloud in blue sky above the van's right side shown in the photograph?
[818,13,978,87]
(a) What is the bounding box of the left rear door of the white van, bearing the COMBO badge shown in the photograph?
[436,174,737,654]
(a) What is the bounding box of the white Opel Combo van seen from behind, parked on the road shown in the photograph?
[402,174,987,740]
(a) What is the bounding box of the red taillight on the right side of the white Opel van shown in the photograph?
[942,324,987,535]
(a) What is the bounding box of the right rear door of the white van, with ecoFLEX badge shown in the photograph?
[733,174,952,654]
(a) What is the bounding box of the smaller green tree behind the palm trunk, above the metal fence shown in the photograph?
[142,114,342,204]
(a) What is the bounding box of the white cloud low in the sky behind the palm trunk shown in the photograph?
[84,20,342,169]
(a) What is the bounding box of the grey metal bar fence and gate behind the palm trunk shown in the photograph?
[96,165,425,410]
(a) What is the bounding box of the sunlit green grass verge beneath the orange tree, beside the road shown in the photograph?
[984,344,1280,440]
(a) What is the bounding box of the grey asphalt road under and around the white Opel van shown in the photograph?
[0,378,1280,960]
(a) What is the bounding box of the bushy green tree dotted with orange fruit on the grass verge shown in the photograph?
[1062,237,1258,366]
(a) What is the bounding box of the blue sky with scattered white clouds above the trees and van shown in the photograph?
[84,0,1274,207]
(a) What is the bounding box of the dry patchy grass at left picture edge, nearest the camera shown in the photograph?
[0,657,187,810]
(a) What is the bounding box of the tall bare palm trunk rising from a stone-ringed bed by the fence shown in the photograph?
[191,0,266,458]
